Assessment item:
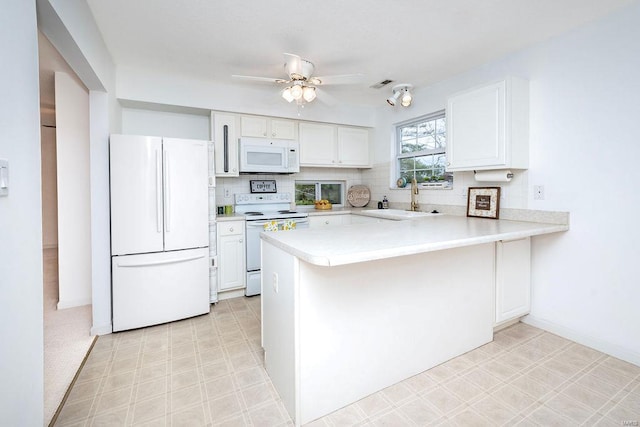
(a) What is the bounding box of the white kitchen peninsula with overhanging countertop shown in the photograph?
[262,215,568,425]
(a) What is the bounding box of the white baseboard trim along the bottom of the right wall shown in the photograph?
[522,315,640,366]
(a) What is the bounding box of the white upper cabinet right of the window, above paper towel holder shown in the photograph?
[447,77,529,171]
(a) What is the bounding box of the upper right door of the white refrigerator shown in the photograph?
[163,138,209,251]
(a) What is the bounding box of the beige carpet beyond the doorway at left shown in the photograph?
[42,249,94,425]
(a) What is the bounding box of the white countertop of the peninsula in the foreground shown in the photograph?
[261,215,569,266]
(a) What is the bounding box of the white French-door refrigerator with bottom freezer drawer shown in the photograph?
[109,135,210,332]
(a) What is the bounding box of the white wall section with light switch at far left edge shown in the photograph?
[0,0,44,426]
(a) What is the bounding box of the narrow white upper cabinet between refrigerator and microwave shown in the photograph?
[211,112,240,177]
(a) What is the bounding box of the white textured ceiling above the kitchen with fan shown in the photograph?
[88,0,632,105]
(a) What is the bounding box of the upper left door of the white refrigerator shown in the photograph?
[109,135,163,255]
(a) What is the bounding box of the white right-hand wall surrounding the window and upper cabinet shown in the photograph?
[365,2,640,364]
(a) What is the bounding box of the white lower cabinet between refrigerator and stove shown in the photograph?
[216,221,246,292]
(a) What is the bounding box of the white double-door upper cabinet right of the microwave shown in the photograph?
[300,123,371,168]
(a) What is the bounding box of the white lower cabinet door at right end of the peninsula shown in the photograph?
[494,237,531,326]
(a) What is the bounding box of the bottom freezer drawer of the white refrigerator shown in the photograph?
[112,248,210,332]
